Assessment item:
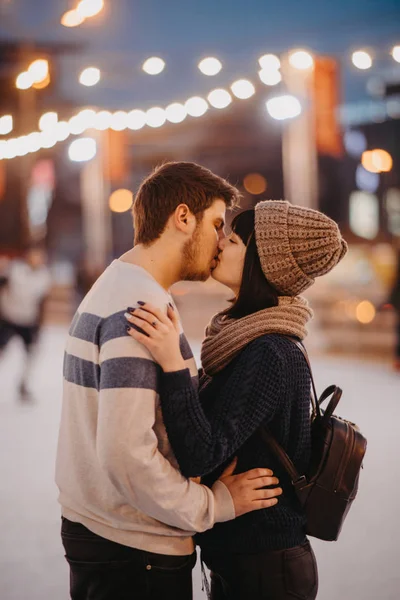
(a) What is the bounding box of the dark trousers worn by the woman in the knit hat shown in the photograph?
[202,541,318,600]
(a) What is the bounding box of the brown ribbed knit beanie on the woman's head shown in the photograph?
[255,200,347,296]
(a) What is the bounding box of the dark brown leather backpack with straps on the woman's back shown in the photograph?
[260,336,367,541]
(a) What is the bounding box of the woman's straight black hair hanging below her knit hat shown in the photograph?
[225,210,279,319]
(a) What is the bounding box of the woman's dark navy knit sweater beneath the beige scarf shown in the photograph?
[161,334,310,553]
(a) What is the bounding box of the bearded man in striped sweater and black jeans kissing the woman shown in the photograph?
[56,162,278,600]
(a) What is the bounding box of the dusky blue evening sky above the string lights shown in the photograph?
[0,0,400,109]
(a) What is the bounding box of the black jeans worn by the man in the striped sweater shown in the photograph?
[61,518,196,600]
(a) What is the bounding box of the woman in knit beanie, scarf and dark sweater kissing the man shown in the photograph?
[126,201,347,600]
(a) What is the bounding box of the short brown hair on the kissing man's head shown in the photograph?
[133,162,240,245]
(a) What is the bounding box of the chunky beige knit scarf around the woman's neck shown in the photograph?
[201,296,313,376]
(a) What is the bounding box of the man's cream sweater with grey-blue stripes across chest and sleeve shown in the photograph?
[56,260,234,555]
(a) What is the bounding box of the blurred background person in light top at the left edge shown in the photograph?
[0,245,51,399]
